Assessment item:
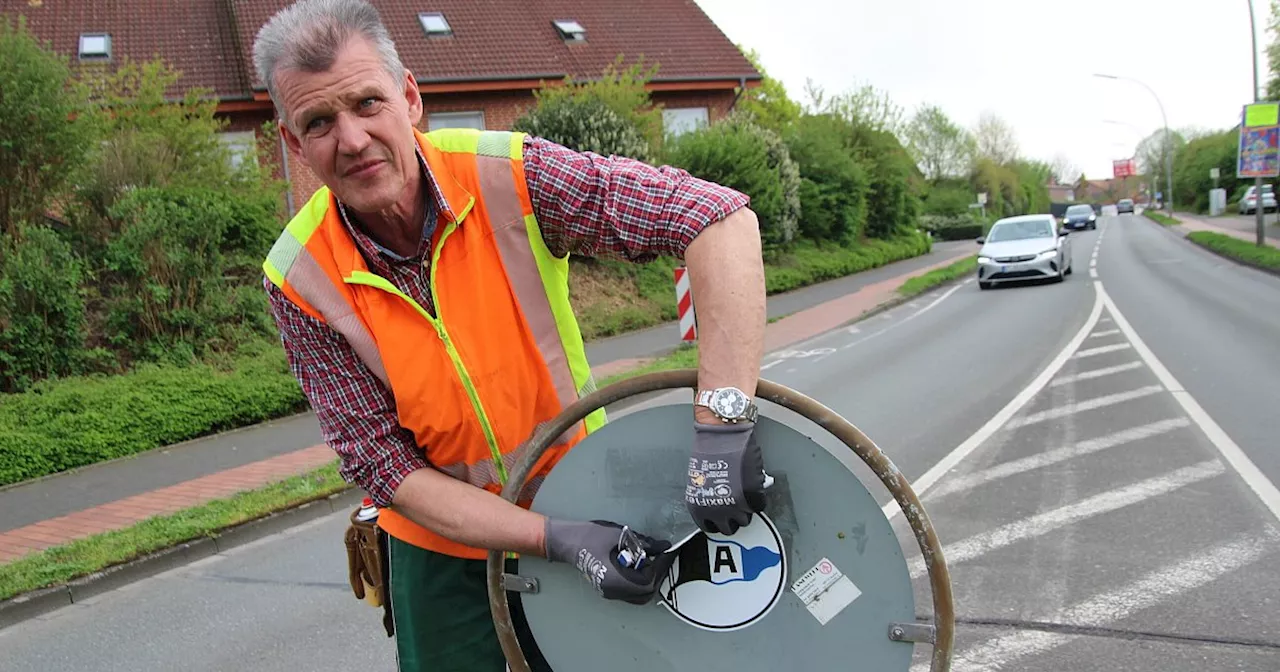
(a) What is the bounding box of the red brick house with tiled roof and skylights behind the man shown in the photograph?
[0,0,760,214]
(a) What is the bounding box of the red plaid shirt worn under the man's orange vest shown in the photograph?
[264,137,749,507]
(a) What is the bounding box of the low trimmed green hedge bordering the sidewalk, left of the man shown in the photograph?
[0,343,306,485]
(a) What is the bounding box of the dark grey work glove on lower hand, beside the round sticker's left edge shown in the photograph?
[547,517,676,604]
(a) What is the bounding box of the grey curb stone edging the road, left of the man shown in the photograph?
[0,488,364,630]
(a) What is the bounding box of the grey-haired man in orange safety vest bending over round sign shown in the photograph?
[253,0,765,672]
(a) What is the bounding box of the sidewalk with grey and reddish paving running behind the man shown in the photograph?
[0,246,973,564]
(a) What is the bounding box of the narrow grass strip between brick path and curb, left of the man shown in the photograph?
[0,461,347,599]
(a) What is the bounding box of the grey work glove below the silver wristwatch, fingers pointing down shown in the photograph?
[685,422,772,535]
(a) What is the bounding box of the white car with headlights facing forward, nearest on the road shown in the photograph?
[978,215,1071,289]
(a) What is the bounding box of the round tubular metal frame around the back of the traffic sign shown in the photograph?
[486,369,955,672]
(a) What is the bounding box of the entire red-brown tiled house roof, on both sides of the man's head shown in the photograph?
[0,0,759,100]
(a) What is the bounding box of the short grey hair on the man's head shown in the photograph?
[253,0,404,123]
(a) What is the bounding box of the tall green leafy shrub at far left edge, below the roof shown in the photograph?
[0,17,93,236]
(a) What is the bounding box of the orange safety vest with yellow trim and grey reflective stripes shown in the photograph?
[262,129,605,559]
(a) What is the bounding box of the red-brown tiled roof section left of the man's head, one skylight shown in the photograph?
[0,0,250,99]
